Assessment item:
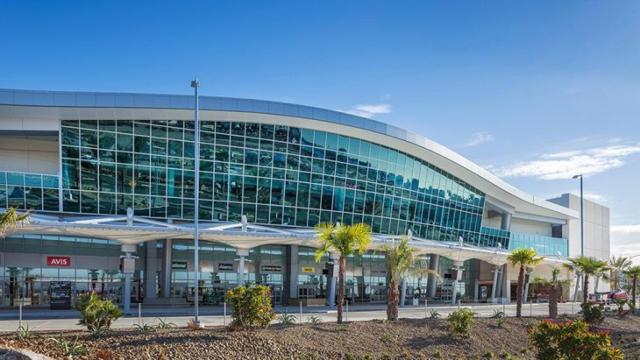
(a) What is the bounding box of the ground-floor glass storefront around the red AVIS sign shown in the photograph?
[0,234,125,306]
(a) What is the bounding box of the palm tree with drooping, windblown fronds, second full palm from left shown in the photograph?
[380,236,437,320]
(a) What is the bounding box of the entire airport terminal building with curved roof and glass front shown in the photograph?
[0,89,609,307]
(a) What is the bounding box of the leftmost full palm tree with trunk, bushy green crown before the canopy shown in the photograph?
[316,223,371,324]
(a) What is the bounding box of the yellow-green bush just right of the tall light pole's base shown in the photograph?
[225,285,276,329]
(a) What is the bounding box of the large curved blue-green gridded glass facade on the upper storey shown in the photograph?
[60,120,496,246]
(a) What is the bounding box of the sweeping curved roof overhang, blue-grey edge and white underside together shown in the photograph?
[0,89,578,221]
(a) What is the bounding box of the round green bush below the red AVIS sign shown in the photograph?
[76,293,122,336]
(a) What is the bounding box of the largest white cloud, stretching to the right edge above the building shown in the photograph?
[494,144,640,180]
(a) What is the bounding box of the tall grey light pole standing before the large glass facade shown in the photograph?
[191,78,204,327]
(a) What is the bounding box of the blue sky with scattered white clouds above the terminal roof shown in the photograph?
[0,0,640,254]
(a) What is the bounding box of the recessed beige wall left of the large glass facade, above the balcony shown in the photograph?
[0,135,59,175]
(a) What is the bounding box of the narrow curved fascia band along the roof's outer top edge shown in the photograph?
[0,89,577,219]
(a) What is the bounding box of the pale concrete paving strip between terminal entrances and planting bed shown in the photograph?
[0,303,580,332]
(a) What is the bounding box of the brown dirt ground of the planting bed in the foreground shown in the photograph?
[0,316,640,360]
